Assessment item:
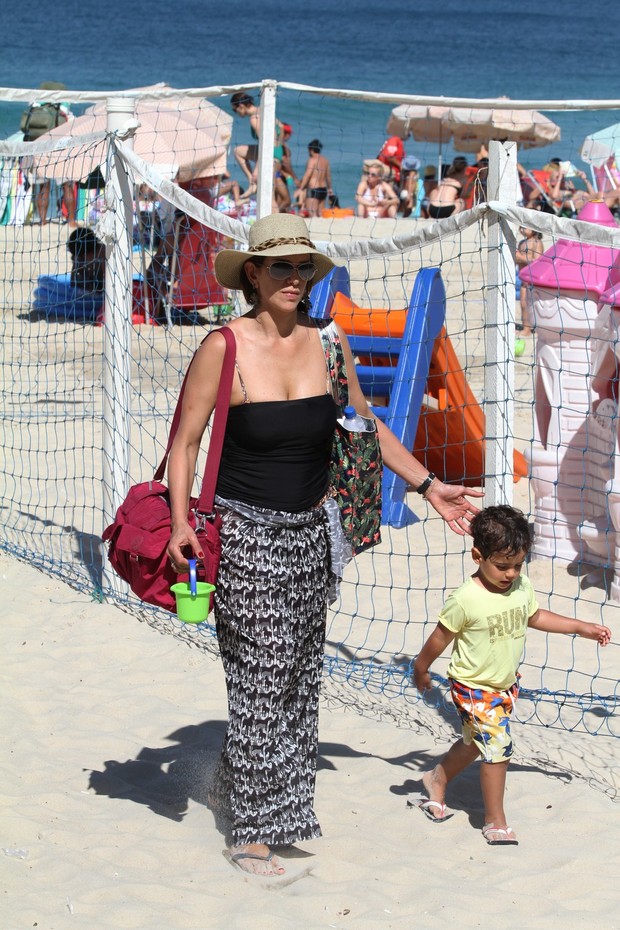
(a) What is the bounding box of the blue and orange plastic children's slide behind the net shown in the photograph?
[311,268,527,527]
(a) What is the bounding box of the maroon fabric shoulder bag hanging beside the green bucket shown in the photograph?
[102,327,235,613]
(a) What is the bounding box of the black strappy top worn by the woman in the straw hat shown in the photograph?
[217,394,338,513]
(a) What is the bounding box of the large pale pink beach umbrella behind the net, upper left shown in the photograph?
[27,94,232,183]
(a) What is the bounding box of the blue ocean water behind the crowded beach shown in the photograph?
[0,0,620,202]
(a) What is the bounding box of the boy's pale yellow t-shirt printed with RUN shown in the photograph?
[439,575,538,691]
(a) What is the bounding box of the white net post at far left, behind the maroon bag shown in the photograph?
[102,97,134,591]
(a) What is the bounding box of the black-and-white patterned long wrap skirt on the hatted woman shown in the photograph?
[211,499,332,846]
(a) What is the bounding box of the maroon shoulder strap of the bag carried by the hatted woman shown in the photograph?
[153,326,237,513]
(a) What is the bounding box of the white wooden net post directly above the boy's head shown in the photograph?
[484,141,519,506]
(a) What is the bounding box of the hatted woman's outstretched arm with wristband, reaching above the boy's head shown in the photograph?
[338,326,483,536]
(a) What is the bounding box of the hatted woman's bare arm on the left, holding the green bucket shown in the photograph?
[168,333,226,570]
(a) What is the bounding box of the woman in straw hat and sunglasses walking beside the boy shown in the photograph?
[168,214,479,875]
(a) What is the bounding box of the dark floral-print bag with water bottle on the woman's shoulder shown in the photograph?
[321,320,383,555]
